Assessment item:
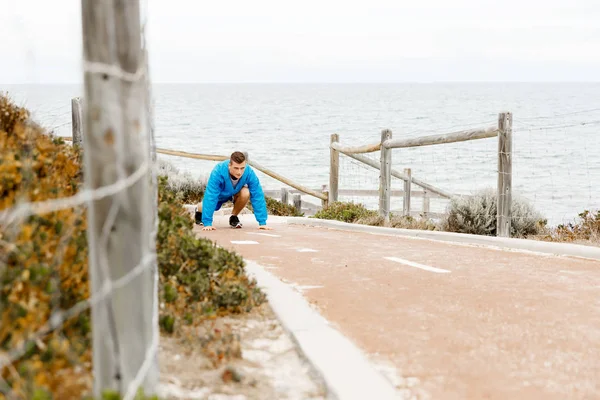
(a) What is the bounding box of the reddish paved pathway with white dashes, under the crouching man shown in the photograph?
[195,215,600,400]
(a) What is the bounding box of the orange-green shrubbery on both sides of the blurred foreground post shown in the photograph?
[0,94,265,399]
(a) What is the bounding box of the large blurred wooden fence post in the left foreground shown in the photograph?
[81,0,159,398]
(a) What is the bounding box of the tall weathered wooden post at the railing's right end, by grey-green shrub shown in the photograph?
[496,112,512,237]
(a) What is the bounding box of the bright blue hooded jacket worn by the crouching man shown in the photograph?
[202,160,267,226]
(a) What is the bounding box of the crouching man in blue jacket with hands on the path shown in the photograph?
[195,151,271,231]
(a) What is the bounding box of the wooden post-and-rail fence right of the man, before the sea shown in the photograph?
[329,112,512,237]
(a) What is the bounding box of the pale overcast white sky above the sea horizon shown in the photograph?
[0,0,600,83]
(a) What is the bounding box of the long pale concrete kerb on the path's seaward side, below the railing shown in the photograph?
[287,217,600,261]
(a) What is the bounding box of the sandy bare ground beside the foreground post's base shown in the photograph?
[159,304,327,400]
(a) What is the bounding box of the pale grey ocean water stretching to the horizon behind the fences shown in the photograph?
[0,83,600,225]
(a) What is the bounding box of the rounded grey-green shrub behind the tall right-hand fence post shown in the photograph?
[442,189,546,238]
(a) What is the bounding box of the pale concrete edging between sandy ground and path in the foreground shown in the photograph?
[245,260,399,400]
